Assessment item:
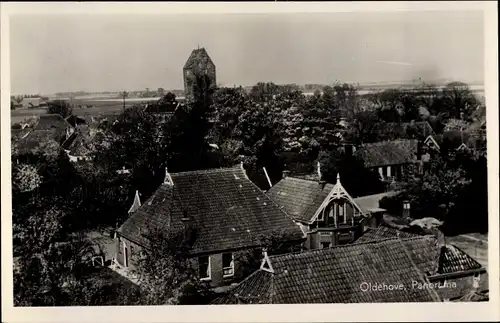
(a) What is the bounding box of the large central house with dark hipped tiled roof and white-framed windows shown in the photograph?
[115,165,305,287]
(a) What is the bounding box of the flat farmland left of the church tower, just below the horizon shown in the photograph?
[10,98,159,124]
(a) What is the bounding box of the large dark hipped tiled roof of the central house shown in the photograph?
[118,167,304,253]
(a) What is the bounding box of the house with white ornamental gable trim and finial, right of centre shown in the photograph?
[266,163,394,249]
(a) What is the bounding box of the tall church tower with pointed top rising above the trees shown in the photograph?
[183,48,217,98]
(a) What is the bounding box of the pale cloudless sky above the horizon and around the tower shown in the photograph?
[10,11,484,94]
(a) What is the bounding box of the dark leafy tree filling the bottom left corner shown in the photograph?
[13,207,102,306]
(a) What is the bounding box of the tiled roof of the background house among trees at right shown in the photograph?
[355,139,418,167]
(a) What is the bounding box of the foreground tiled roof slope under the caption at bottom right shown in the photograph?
[214,236,439,304]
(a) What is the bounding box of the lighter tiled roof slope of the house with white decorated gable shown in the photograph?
[266,177,334,222]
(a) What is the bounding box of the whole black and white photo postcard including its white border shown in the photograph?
[2,3,500,320]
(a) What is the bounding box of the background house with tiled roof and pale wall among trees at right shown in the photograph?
[355,139,420,182]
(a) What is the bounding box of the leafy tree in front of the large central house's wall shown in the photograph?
[134,230,210,305]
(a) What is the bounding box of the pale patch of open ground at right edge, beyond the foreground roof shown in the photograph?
[446,233,488,268]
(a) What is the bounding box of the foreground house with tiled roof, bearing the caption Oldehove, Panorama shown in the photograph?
[213,226,488,304]
